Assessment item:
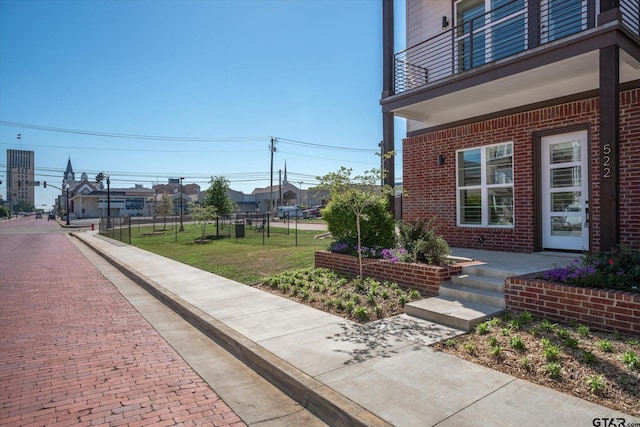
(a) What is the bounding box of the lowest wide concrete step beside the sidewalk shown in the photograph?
[404,297,504,332]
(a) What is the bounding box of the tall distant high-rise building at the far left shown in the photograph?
[7,149,35,212]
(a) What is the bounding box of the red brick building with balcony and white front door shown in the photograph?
[381,0,640,253]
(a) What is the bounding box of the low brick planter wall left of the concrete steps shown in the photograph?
[315,251,462,296]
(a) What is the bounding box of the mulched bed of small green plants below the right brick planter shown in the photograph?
[433,311,640,417]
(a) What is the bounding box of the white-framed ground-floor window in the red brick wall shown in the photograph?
[456,142,513,227]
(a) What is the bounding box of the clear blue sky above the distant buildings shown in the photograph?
[0,0,404,207]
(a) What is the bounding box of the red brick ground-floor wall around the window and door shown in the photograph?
[402,89,640,253]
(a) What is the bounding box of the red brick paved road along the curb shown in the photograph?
[0,221,245,426]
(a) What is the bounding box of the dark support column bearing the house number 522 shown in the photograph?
[598,45,620,251]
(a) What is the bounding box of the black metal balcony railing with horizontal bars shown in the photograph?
[394,0,640,93]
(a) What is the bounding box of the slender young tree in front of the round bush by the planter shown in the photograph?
[317,153,394,278]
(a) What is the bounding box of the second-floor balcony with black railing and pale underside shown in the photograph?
[382,0,640,130]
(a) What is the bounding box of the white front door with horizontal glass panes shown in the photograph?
[541,131,589,251]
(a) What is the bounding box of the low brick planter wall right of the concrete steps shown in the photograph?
[504,274,640,336]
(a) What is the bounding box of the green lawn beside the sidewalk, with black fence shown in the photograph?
[131,224,329,284]
